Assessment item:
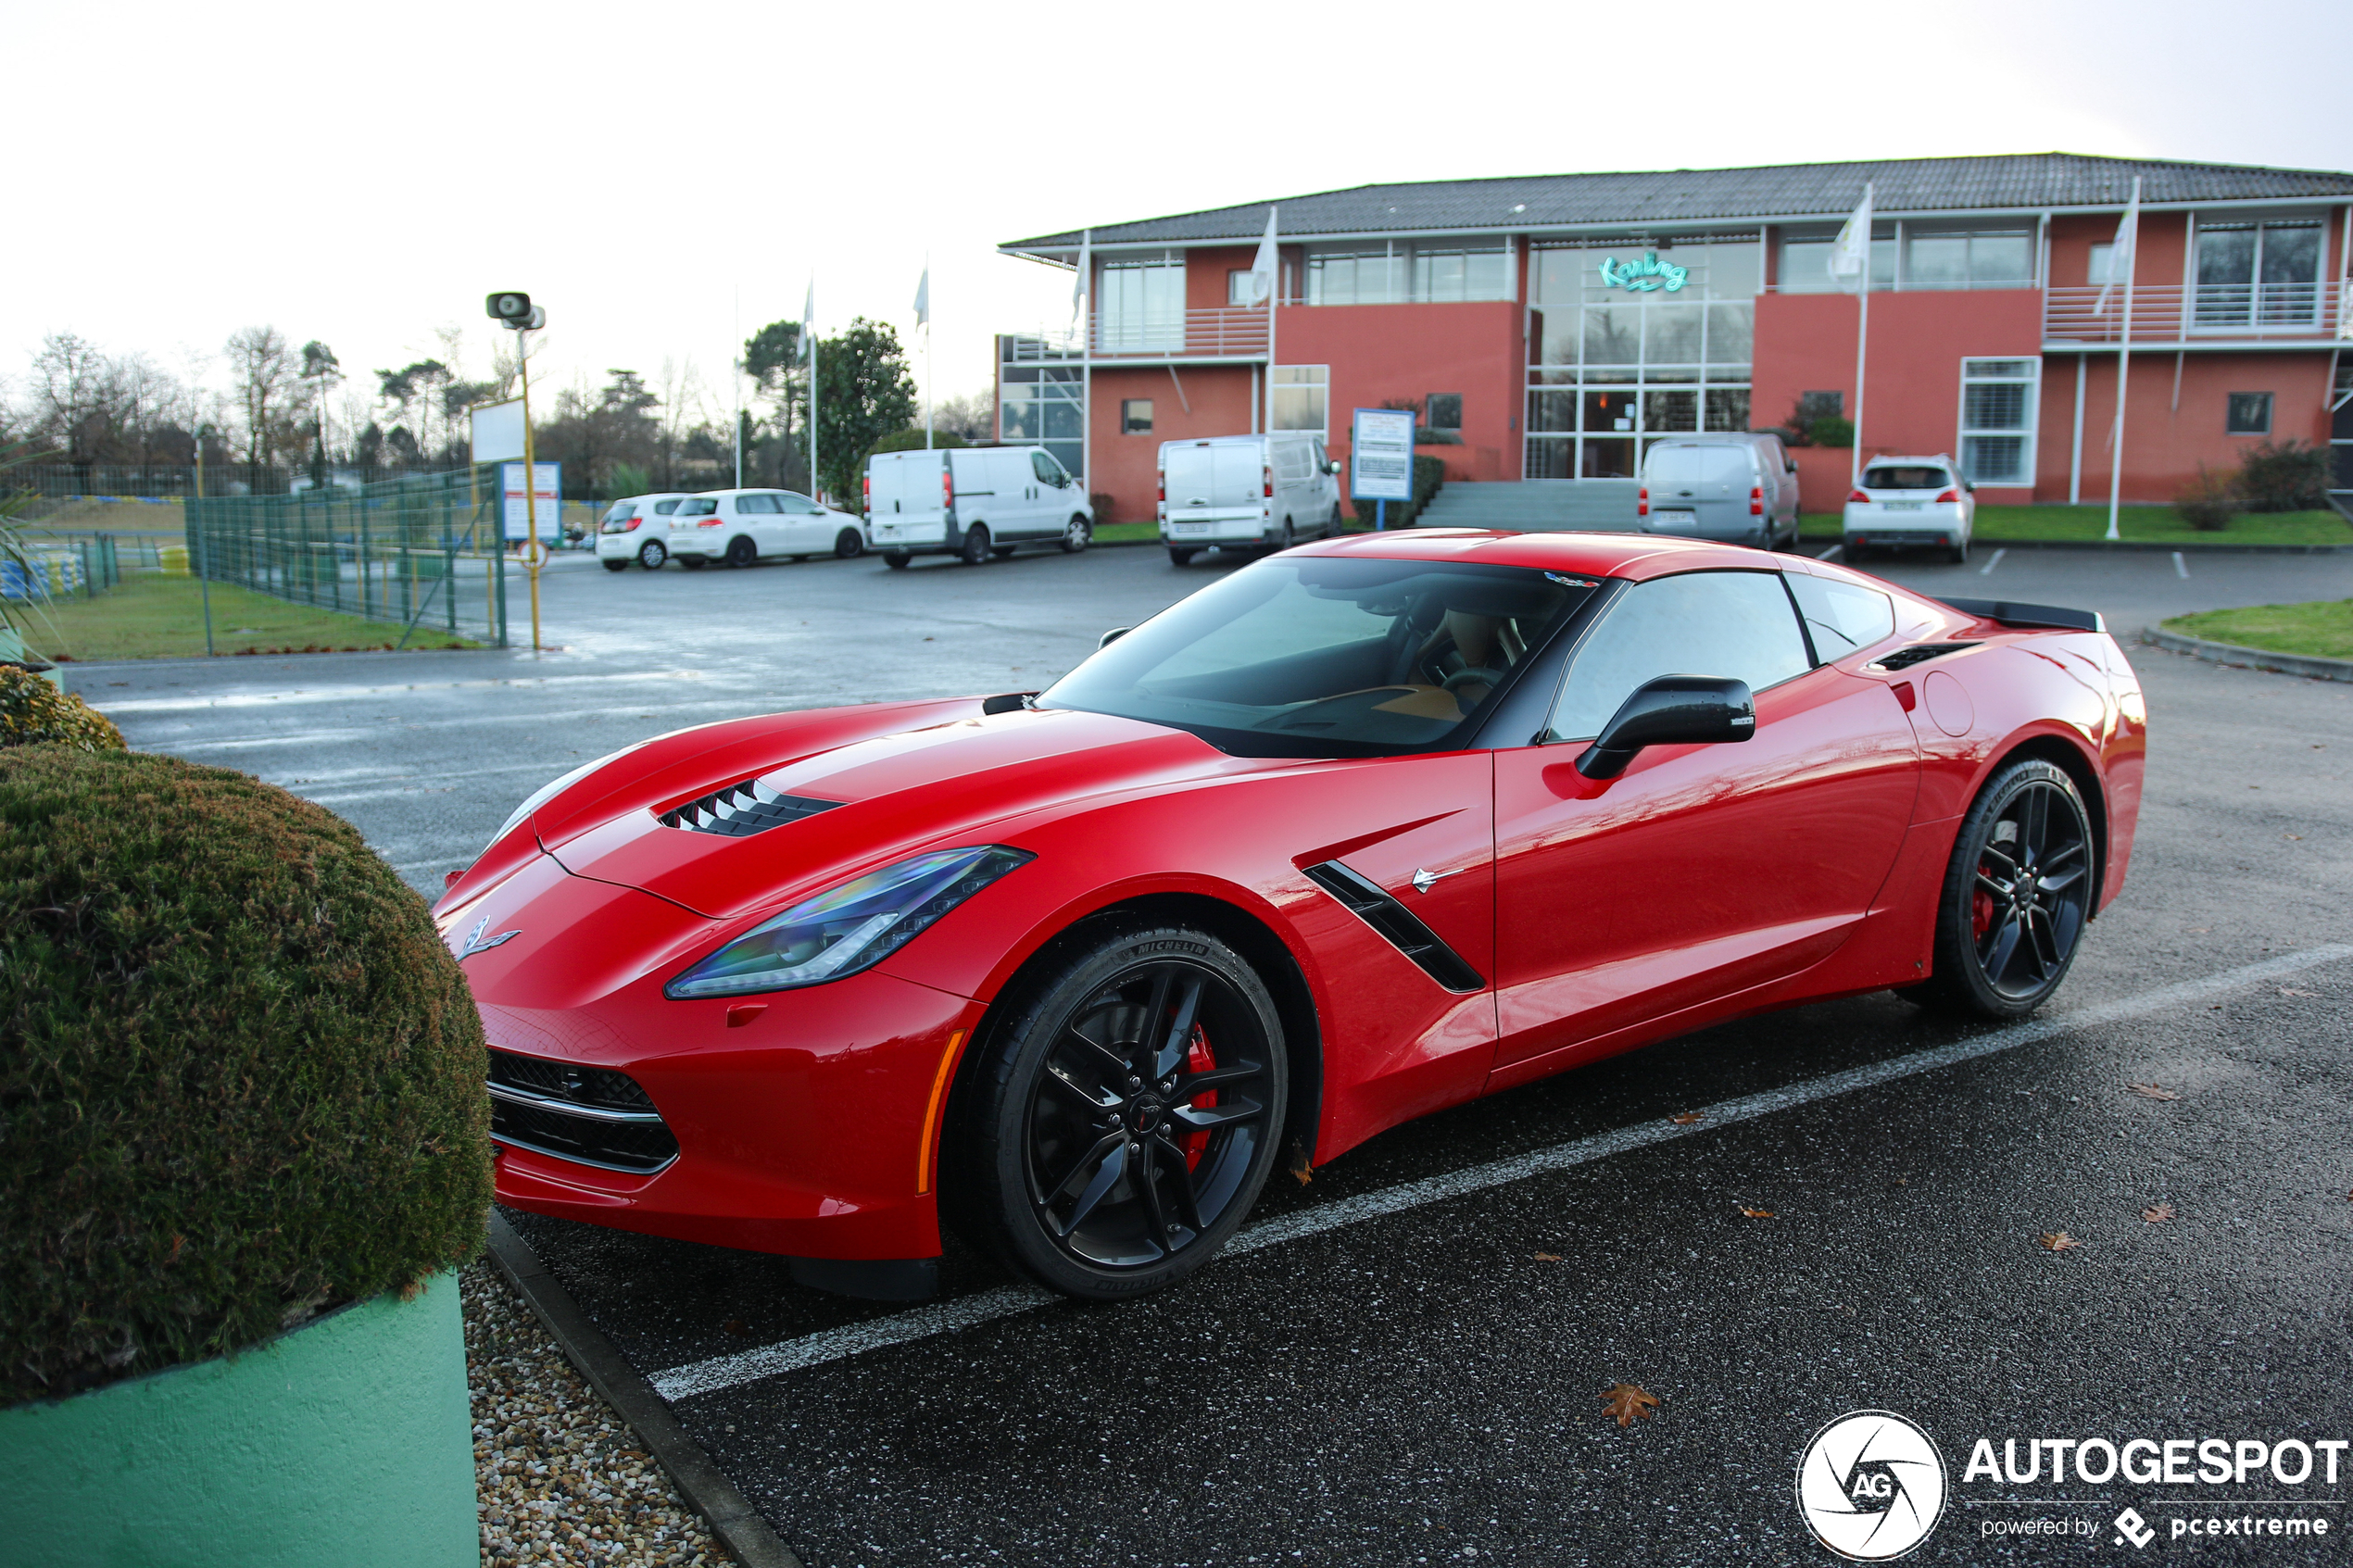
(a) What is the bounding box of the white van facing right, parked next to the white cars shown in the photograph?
[866,446,1094,567]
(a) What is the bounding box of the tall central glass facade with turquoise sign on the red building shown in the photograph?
[1525,232,1762,480]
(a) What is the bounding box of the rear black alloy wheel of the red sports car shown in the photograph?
[1904,759,2099,1018]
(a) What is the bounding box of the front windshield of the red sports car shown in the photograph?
[1038,555,1595,757]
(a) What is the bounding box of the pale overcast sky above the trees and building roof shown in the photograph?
[18,0,2353,430]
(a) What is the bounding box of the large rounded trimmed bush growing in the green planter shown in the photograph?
[0,746,489,1406]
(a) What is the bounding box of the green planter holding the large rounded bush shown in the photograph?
[0,1274,483,1568]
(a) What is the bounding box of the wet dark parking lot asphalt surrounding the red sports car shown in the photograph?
[70,535,2353,1568]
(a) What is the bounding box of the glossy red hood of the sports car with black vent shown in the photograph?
[536,700,1268,919]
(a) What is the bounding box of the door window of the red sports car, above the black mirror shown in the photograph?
[1551,571,1809,741]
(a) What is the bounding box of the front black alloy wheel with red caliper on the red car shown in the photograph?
[946,924,1285,1300]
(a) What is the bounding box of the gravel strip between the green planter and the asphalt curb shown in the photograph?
[459,1258,734,1568]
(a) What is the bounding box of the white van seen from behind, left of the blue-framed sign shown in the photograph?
[1160,430,1339,567]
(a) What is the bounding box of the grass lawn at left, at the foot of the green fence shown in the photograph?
[9,571,478,659]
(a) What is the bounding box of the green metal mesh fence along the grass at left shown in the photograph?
[186,470,506,649]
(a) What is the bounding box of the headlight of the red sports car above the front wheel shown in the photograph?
[661,844,1036,1001]
